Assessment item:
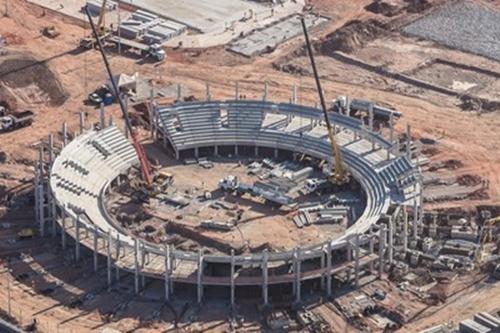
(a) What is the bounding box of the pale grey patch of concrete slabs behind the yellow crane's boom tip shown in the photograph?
[229,15,328,57]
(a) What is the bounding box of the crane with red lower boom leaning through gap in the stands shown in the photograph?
[85,6,152,186]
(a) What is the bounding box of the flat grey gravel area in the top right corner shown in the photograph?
[403,2,500,61]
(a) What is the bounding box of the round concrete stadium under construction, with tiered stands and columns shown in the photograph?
[35,94,422,305]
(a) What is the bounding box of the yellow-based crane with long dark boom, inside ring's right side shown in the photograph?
[300,16,350,186]
